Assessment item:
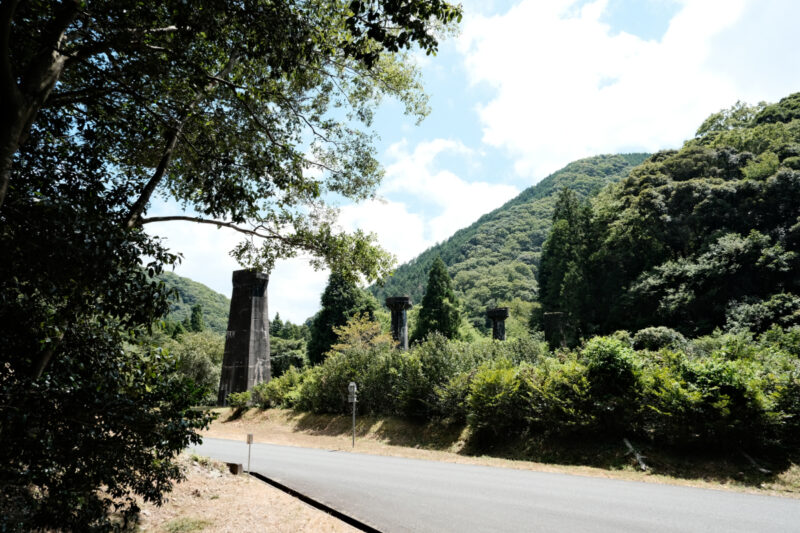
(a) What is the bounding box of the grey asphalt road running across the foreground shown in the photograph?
[195,439,800,533]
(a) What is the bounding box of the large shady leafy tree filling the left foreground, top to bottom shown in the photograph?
[0,0,460,531]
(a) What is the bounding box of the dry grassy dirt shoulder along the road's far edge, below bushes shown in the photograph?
[204,409,800,498]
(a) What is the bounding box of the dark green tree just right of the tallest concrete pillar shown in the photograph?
[308,272,378,365]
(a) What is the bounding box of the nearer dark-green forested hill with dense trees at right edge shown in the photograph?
[539,93,800,342]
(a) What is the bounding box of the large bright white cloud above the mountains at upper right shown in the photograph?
[459,0,800,179]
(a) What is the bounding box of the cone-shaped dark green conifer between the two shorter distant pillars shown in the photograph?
[412,257,461,340]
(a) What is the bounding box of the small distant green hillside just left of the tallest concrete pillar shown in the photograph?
[161,272,231,335]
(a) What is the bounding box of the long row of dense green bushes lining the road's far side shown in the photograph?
[254,318,800,449]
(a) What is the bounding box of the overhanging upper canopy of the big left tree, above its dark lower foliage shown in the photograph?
[0,0,460,278]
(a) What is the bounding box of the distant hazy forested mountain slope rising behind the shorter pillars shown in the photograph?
[370,154,648,327]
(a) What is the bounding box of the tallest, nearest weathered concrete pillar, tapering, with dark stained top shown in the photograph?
[217,270,270,405]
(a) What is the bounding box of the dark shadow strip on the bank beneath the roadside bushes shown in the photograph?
[291,412,800,493]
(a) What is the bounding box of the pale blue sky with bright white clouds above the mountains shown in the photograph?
[148,0,800,323]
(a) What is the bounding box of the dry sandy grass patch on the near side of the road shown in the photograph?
[139,456,356,533]
